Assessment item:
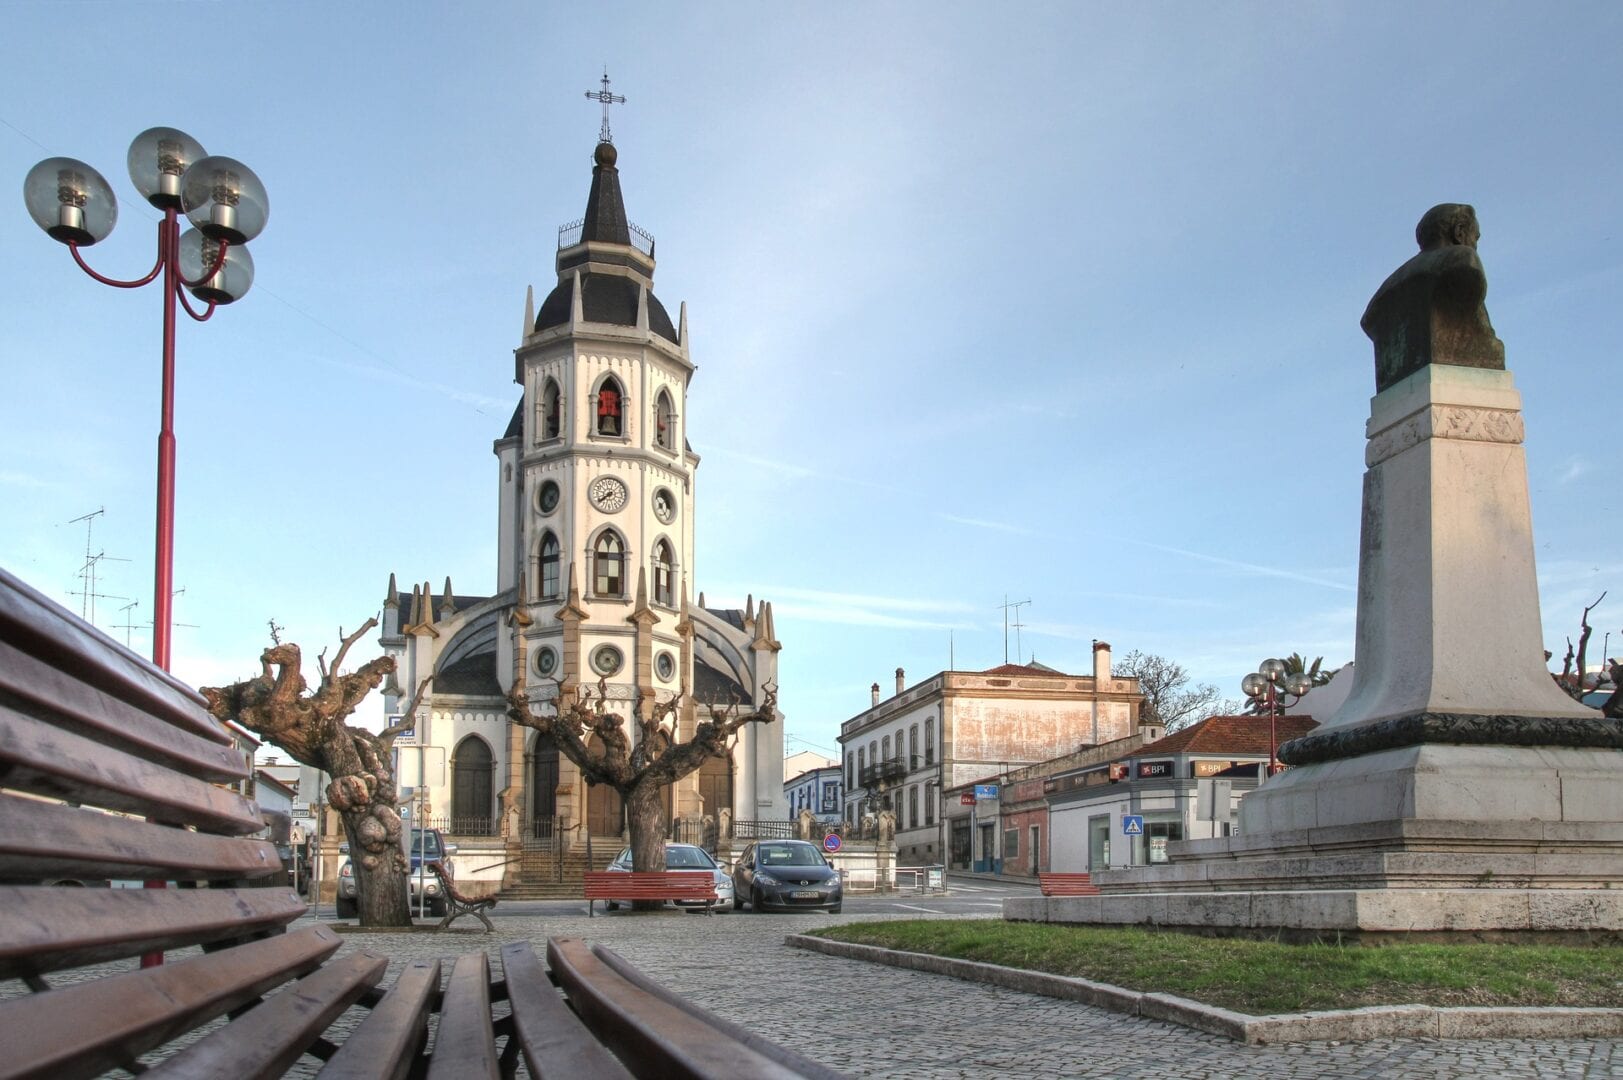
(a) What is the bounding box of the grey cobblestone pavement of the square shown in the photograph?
[306,911,1623,1080]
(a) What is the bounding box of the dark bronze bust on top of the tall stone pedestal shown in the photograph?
[1360,203,1505,393]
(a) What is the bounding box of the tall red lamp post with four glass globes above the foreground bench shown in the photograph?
[23,128,269,671]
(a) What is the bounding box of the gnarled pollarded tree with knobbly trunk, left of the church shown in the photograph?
[203,619,430,926]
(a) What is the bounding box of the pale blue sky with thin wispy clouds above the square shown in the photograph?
[0,0,1623,749]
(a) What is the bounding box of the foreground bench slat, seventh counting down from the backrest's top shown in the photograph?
[146,952,390,1080]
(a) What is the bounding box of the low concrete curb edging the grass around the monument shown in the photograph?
[784,934,1623,1046]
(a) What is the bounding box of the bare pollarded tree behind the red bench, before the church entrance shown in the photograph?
[508,609,777,889]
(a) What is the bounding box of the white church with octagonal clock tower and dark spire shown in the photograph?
[380,130,789,849]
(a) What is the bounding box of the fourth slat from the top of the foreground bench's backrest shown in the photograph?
[0,793,284,882]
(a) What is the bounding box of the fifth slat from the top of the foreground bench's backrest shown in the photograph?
[0,885,308,978]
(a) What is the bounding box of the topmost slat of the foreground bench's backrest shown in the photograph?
[0,570,230,745]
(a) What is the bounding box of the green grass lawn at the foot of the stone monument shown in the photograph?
[815,919,1623,1015]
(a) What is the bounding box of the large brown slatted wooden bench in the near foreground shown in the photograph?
[0,570,837,1080]
